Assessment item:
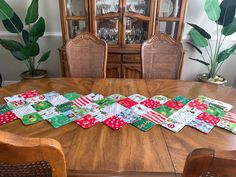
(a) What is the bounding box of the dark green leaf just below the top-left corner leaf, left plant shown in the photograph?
[2,13,24,33]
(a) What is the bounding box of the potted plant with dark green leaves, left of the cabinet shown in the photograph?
[0,0,50,79]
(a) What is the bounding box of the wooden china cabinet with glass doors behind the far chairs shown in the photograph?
[59,0,187,78]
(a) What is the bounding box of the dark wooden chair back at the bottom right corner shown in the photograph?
[182,149,236,177]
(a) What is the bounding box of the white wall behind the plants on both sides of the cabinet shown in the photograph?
[0,0,236,86]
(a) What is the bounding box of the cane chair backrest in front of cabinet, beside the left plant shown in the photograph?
[66,32,107,78]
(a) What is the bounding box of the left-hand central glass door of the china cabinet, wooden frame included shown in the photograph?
[93,0,122,46]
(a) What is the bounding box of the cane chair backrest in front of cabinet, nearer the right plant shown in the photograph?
[141,33,184,79]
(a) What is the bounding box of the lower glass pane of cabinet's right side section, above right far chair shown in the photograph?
[159,22,179,39]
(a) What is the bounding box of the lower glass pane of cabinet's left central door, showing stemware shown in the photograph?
[97,17,119,44]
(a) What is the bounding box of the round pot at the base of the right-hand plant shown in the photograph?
[197,73,227,85]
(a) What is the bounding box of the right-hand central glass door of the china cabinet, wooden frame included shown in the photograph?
[123,0,155,45]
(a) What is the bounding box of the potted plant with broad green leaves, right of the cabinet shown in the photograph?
[188,0,236,84]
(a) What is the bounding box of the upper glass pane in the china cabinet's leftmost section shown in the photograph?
[66,0,85,16]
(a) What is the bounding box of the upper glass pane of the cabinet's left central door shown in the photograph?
[96,0,119,16]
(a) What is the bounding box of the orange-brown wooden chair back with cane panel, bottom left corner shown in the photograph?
[0,131,66,177]
